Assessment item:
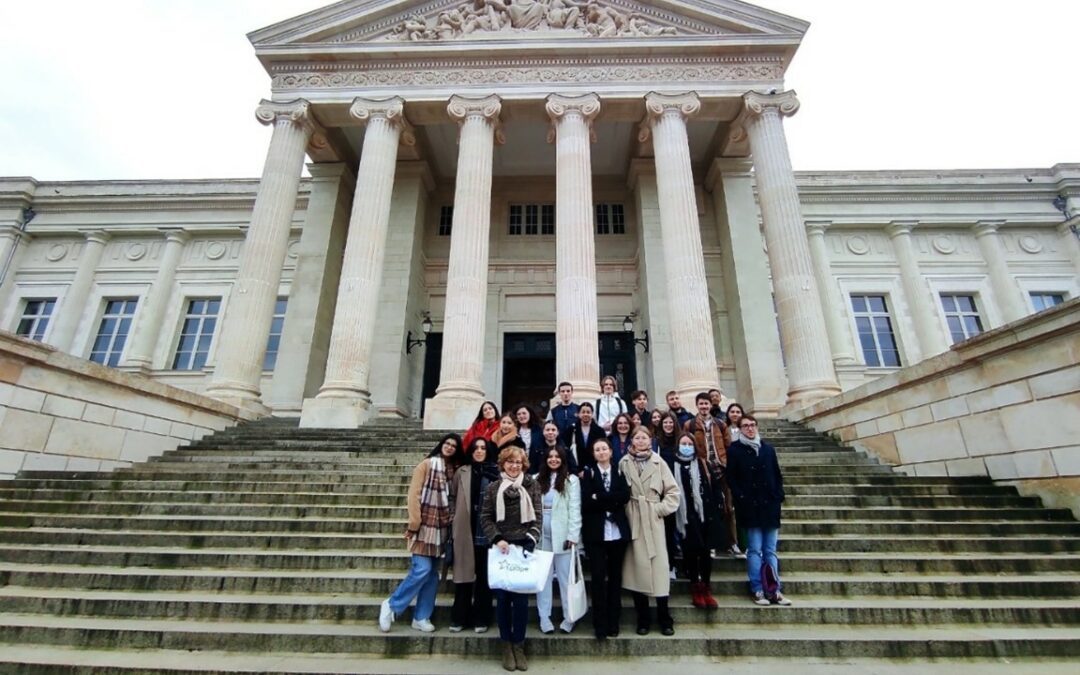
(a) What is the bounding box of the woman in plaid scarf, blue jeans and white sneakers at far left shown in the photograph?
[379,433,462,633]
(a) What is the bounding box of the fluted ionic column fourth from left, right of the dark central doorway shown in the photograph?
[545,94,600,400]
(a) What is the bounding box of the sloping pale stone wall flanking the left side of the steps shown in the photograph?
[0,332,247,478]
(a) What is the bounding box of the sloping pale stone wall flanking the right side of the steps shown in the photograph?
[793,299,1080,516]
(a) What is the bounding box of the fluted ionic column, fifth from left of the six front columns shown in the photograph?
[640,93,718,400]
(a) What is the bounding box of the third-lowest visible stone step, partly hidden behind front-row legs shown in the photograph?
[0,586,1080,632]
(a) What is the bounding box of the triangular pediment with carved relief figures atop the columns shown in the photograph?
[248,0,808,49]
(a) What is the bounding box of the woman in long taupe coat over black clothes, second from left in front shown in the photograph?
[450,438,499,633]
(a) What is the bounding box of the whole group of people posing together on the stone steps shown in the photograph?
[379,377,791,671]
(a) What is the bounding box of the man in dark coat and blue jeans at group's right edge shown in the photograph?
[727,415,792,606]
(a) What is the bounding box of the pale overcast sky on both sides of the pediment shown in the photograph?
[0,0,1080,180]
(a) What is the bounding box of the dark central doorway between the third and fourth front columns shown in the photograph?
[500,333,557,419]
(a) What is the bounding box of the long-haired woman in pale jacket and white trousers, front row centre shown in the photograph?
[537,447,581,633]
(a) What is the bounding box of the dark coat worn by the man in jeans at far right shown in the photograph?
[727,442,784,529]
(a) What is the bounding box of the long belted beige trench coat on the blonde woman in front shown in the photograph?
[619,453,679,597]
